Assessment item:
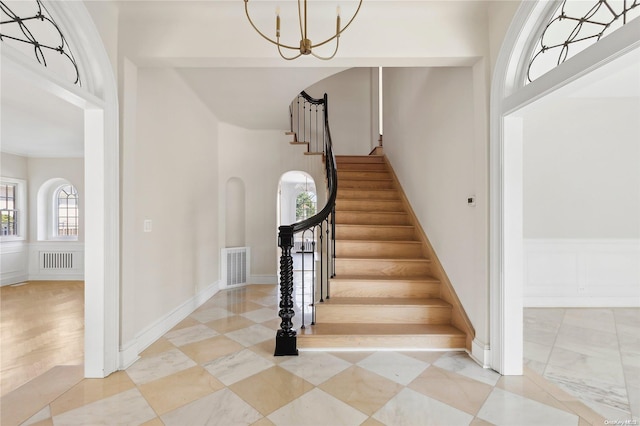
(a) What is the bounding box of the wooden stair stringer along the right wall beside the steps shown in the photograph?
[381,154,476,352]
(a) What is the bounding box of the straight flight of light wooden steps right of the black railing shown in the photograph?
[298,155,473,350]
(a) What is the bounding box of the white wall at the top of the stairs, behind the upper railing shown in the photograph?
[305,68,378,155]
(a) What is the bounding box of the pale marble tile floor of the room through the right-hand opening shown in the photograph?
[524,308,640,424]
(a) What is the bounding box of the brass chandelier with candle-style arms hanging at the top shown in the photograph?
[244,0,362,61]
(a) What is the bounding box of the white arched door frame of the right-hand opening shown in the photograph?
[489,1,640,375]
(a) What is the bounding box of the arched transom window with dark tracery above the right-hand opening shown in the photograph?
[525,0,640,84]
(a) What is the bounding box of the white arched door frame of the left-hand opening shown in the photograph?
[2,2,120,378]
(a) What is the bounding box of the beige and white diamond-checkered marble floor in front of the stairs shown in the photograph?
[1,285,616,426]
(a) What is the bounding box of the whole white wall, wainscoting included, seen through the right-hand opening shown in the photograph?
[523,97,640,306]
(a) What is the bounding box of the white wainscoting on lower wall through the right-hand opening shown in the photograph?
[524,239,640,307]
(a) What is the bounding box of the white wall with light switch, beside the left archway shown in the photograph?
[121,64,220,346]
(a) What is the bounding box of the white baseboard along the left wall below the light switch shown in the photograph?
[119,282,220,370]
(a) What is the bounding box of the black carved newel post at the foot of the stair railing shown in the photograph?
[274,225,298,356]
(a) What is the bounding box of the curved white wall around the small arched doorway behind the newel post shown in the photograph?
[218,123,325,284]
